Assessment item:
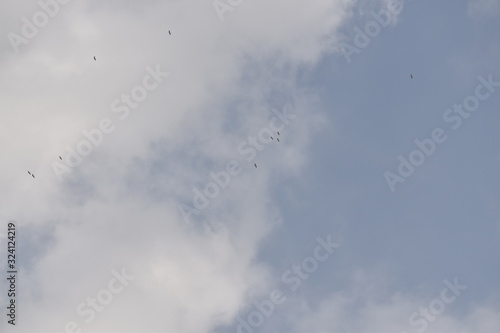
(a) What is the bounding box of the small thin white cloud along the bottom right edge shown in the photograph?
[289,272,500,333]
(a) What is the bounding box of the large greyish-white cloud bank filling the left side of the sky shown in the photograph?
[0,0,360,333]
